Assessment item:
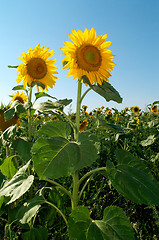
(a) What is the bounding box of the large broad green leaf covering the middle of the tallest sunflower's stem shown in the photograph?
[32,131,97,179]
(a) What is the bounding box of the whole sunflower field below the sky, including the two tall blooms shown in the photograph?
[0,28,159,240]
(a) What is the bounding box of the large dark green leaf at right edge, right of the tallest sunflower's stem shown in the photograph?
[107,149,159,206]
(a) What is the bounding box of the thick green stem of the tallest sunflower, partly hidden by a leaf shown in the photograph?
[72,79,82,209]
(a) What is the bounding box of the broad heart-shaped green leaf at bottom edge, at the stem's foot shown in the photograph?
[68,206,134,240]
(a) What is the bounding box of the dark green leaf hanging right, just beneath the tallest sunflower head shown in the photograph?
[82,76,122,103]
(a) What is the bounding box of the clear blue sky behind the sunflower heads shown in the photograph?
[0,0,159,111]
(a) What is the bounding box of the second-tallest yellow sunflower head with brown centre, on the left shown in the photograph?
[17,44,57,91]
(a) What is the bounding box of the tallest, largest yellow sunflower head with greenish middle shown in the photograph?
[61,28,115,85]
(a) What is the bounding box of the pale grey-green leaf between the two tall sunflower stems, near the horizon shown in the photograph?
[35,99,72,113]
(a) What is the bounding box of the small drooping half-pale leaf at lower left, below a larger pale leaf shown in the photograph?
[16,195,45,224]
